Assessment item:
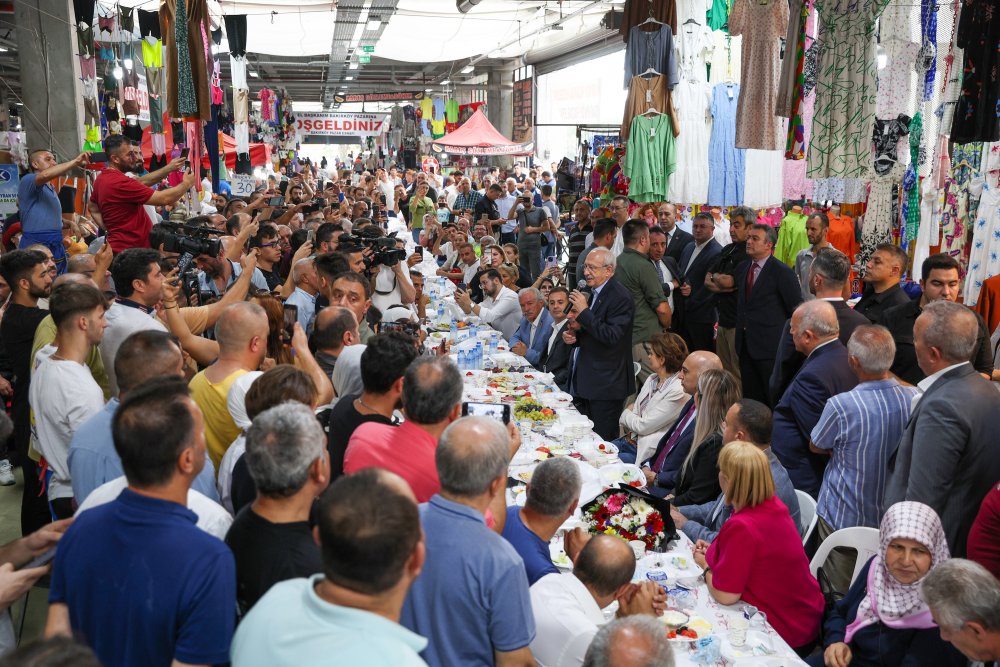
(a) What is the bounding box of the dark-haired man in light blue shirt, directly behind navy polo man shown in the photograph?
[68,332,219,505]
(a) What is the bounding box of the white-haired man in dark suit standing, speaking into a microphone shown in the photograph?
[563,248,635,440]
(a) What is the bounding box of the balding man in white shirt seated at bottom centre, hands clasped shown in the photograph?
[531,536,665,667]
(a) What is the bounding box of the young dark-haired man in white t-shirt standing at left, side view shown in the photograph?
[28,283,108,519]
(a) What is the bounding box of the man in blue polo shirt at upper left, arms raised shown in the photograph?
[17,149,90,273]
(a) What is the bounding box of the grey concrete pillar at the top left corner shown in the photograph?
[14,0,83,161]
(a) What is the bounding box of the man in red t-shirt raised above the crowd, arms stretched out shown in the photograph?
[91,134,195,253]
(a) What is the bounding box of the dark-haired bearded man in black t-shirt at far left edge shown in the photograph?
[0,250,54,535]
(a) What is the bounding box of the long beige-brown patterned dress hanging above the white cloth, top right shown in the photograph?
[729,0,788,151]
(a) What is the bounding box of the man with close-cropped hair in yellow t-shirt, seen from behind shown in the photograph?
[190,302,268,469]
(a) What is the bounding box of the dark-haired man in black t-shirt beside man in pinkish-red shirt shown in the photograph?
[327,332,417,481]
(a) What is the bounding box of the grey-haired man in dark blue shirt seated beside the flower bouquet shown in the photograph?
[503,456,583,585]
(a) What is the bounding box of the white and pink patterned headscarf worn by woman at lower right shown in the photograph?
[844,501,951,644]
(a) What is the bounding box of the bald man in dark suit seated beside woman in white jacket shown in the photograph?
[636,350,722,497]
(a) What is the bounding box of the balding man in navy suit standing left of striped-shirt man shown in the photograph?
[771,299,858,498]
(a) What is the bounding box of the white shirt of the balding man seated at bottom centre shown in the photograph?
[529,572,605,667]
